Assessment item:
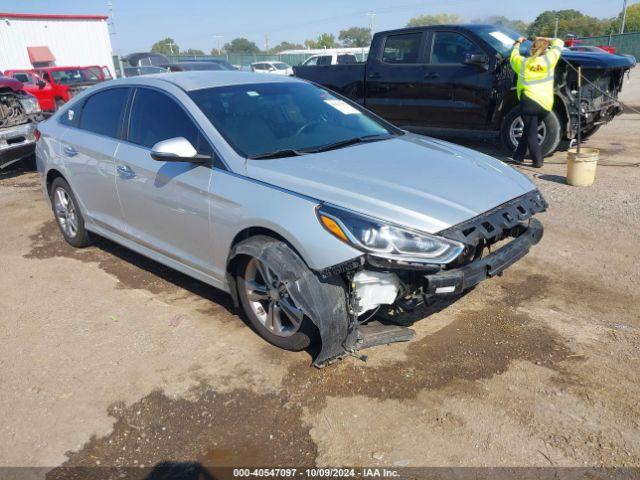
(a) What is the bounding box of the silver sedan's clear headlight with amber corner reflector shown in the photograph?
[317,205,464,264]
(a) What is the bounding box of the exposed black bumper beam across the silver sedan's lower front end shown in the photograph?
[424,218,544,296]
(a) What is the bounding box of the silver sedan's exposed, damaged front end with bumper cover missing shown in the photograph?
[315,190,548,366]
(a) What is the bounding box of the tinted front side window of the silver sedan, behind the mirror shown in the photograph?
[129,88,212,155]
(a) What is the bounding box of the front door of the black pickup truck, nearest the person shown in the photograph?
[422,30,493,129]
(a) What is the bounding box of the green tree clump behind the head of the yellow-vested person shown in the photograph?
[527,10,611,37]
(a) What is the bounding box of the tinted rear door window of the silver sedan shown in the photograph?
[79,88,129,138]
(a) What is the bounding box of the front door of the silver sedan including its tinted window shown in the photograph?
[116,87,213,272]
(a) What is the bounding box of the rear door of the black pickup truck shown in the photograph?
[365,31,426,125]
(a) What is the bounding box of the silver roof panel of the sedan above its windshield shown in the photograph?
[112,70,304,92]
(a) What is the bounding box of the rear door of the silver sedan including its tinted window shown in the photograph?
[61,87,131,231]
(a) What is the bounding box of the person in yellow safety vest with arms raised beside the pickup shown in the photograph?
[510,37,564,168]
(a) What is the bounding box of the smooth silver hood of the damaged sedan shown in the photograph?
[247,133,535,233]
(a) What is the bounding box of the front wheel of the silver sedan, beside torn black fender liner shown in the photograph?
[236,236,317,351]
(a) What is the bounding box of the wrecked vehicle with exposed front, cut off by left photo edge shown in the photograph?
[0,76,42,169]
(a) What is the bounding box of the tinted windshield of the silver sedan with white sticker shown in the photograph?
[189,82,399,157]
